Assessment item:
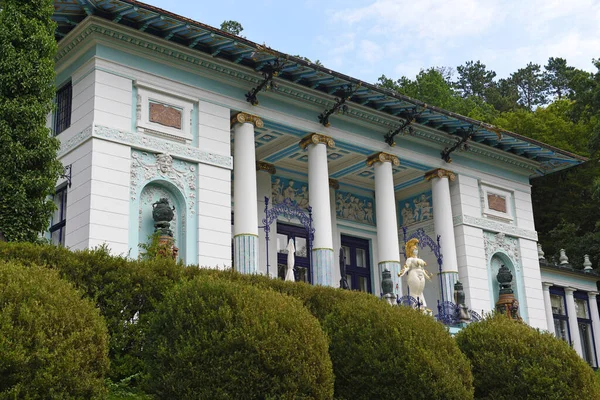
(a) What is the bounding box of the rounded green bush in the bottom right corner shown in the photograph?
[456,315,600,400]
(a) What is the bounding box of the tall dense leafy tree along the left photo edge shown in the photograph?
[0,0,62,241]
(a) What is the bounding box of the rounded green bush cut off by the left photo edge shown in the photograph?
[0,261,108,399]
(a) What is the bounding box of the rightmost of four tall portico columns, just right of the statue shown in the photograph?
[425,169,458,301]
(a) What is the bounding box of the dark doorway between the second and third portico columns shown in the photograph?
[342,235,372,293]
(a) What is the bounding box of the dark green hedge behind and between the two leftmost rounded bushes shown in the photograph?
[0,243,184,380]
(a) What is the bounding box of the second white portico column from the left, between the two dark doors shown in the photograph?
[300,133,335,286]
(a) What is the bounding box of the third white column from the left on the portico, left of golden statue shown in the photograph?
[367,153,402,296]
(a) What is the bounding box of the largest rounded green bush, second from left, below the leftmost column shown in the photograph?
[147,276,333,399]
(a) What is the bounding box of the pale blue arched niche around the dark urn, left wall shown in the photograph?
[137,179,188,263]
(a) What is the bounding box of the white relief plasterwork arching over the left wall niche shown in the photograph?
[129,150,196,214]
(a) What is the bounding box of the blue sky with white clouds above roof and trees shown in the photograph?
[145,0,600,83]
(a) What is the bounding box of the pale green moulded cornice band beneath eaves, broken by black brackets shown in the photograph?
[55,17,541,173]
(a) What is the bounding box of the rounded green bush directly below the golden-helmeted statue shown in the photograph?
[323,297,473,400]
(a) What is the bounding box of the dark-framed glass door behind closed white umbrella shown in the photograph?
[277,222,312,283]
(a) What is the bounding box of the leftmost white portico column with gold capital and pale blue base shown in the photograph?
[231,113,263,274]
